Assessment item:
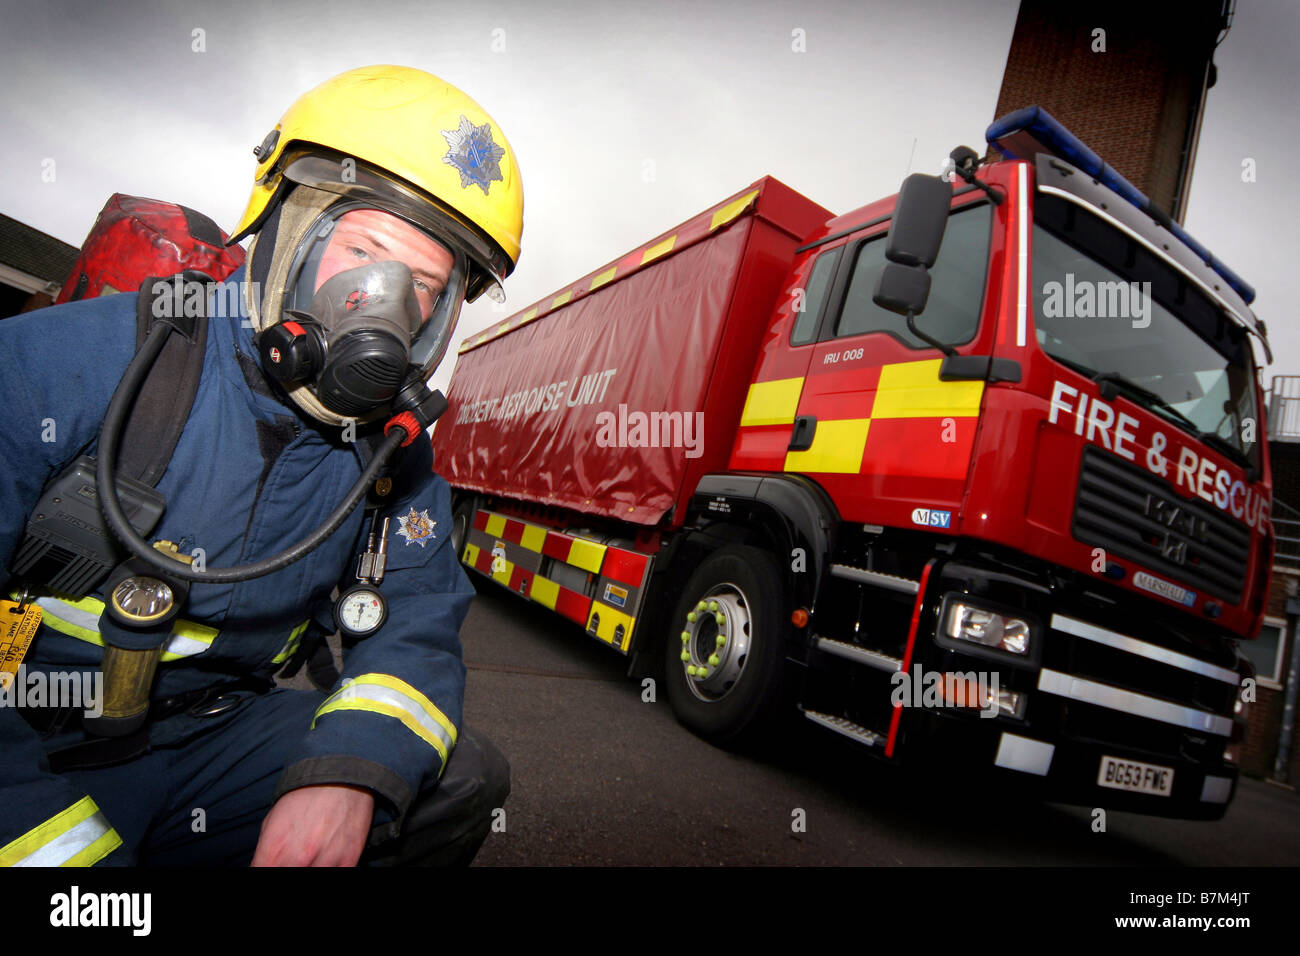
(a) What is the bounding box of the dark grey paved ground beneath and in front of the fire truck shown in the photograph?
[462,584,1300,866]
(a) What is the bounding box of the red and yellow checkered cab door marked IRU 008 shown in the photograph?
[781,200,996,533]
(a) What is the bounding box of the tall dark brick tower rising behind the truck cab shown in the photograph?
[996,0,1222,218]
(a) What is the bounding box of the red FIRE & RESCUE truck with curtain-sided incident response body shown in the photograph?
[433,107,1273,819]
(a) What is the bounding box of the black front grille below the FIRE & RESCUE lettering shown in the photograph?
[1073,447,1251,604]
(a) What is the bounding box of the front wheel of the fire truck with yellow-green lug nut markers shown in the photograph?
[666,545,785,745]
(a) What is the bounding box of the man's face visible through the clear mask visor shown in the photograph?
[312,209,455,321]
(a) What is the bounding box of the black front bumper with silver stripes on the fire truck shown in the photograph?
[904,566,1242,819]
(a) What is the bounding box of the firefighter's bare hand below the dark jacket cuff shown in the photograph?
[252,784,374,866]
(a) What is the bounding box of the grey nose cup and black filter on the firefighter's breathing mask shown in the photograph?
[257,261,421,416]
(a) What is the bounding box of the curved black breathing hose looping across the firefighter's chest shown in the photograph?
[95,319,408,584]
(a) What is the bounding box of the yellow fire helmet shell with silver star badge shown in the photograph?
[230,66,524,306]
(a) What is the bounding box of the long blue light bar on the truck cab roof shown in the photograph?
[984,107,1255,304]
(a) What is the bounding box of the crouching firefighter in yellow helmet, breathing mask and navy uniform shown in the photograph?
[0,66,523,865]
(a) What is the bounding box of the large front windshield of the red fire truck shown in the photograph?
[1031,194,1258,467]
